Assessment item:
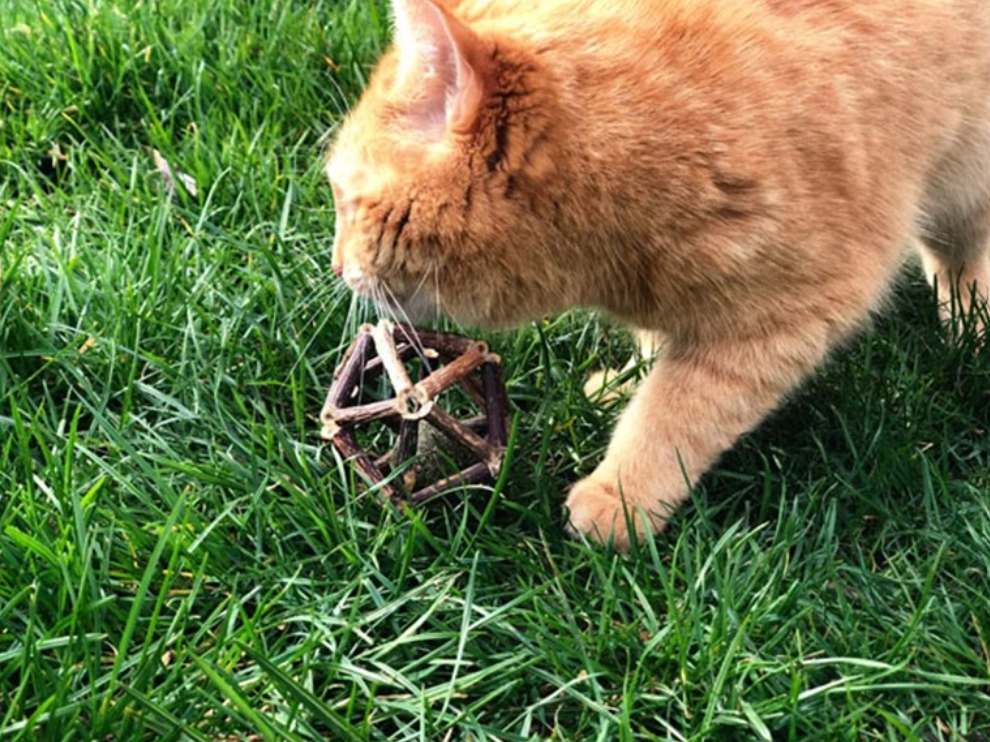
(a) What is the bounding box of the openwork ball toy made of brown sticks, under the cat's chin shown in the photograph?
[320,320,508,504]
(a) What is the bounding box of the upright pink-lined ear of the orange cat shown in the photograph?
[392,0,487,133]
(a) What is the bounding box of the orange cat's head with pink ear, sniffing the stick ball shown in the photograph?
[326,0,568,325]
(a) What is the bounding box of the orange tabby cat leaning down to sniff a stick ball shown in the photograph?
[327,0,990,548]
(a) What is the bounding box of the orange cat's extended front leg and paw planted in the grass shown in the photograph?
[566,320,840,550]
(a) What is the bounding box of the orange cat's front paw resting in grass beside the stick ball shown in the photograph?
[564,476,666,551]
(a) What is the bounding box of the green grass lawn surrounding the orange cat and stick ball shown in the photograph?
[0,0,990,742]
